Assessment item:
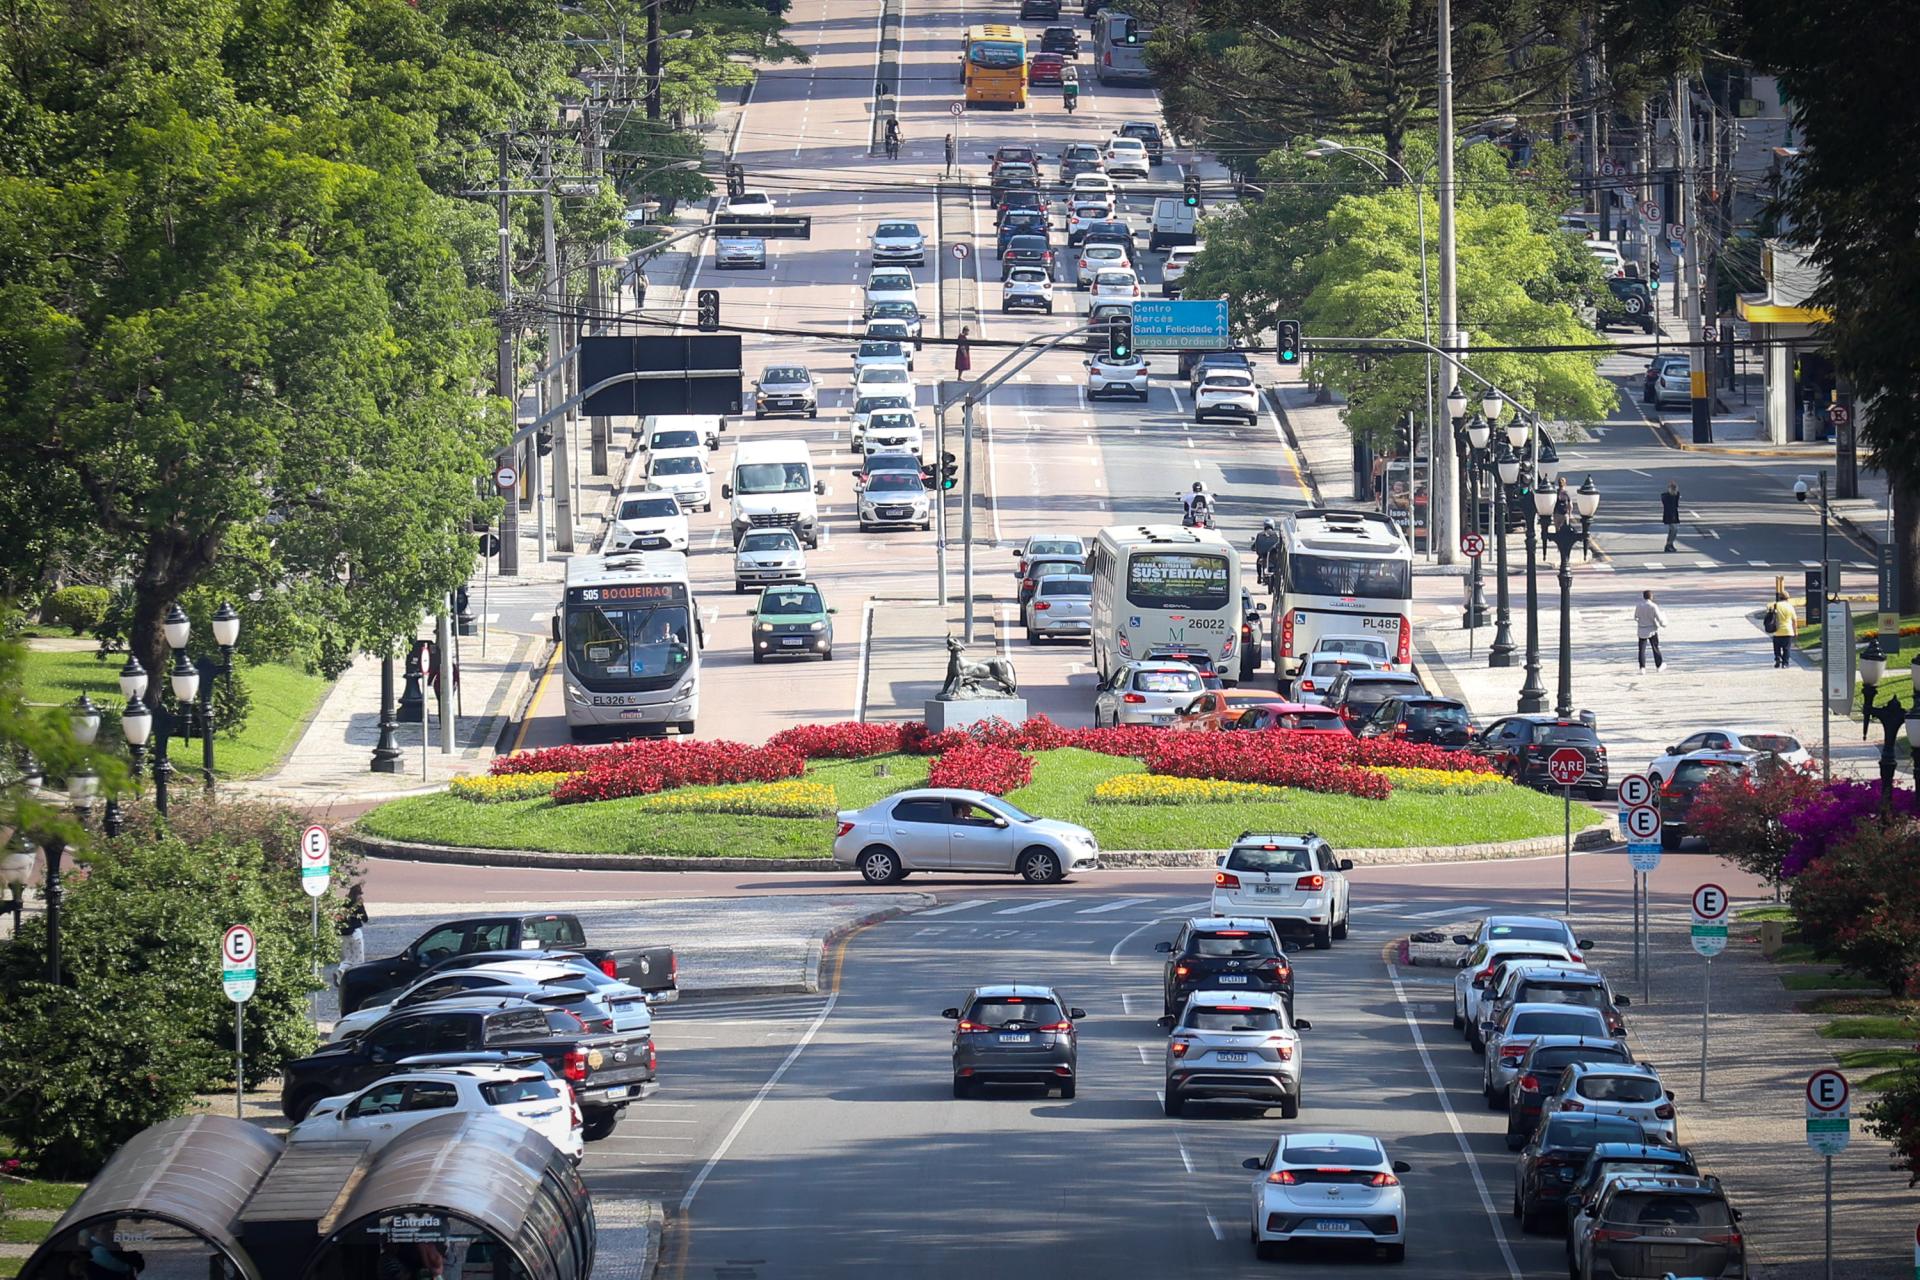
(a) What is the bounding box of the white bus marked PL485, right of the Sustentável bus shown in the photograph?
[1271,507,1413,687]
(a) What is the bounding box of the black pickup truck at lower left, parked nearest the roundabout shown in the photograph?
[340,912,680,1013]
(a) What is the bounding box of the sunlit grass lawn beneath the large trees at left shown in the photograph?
[21,649,332,777]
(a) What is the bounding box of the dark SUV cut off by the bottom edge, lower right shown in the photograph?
[1572,1173,1747,1280]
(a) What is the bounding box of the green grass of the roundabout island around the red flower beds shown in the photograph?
[357,748,1603,858]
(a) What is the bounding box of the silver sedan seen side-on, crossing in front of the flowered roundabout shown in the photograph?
[833,787,1100,885]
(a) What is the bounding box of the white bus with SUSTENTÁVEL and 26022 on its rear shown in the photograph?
[1087,524,1240,683]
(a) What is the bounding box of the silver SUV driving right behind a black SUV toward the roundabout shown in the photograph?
[1160,990,1313,1121]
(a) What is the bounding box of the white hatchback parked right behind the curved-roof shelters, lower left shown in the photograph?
[288,1065,586,1165]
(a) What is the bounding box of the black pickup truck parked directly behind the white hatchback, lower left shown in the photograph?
[280,1000,657,1142]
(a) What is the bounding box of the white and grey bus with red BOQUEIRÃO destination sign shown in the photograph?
[553,551,701,737]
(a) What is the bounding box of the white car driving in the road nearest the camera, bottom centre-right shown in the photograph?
[1244,1134,1411,1263]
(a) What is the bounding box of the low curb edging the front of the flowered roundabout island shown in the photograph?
[334,825,1615,871]
